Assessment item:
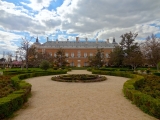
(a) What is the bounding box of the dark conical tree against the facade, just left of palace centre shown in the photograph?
[54,48,68,67]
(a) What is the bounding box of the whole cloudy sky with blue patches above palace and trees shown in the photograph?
[0,0,160,58]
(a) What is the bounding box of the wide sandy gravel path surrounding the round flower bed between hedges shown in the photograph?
[12,70,156,120]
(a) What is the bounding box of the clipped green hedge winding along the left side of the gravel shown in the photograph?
[0,70,67,120]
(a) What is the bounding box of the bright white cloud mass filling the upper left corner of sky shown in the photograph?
[0,1,61,35]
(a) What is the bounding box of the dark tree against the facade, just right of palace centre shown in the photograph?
[88,48,106,68]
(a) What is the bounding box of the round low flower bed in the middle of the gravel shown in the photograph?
[51,74,107,82]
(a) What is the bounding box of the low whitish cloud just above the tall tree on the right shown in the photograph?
[97,24,160,43]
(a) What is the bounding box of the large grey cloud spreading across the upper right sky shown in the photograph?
[58,0,160,37]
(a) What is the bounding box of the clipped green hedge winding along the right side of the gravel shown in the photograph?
[92,70,160,119]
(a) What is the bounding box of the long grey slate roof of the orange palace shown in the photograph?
[36,41,118,48]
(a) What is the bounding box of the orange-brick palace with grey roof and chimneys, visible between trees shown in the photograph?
[33,37,118,67]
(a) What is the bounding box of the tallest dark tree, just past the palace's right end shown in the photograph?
[120,32,142,69]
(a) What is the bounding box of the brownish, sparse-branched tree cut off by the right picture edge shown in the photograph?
[142,34,160,70]
